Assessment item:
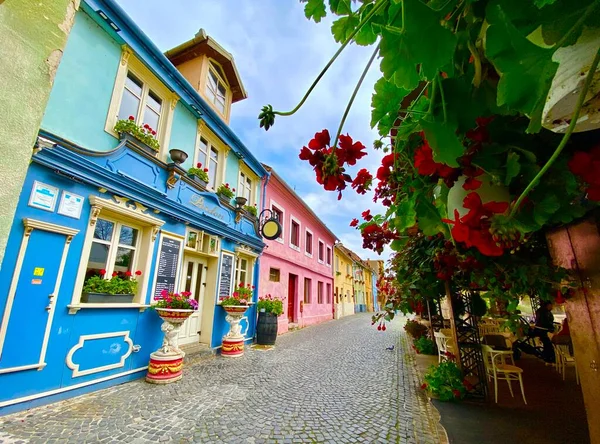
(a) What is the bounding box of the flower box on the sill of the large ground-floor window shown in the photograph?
[81,270,142,304]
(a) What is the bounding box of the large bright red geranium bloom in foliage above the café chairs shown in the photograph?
[444,193,508,256]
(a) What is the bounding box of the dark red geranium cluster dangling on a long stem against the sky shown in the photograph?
[299,129,367,200]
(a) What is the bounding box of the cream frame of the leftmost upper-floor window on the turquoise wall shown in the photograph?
[104,45,179,160]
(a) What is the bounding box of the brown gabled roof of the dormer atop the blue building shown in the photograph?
[165,28,248,103]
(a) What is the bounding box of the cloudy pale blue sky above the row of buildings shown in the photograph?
[118,0,390,260]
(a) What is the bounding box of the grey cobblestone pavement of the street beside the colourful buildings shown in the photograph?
[0,314,445,444]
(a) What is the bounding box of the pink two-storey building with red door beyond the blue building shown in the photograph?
[258,165,337,334]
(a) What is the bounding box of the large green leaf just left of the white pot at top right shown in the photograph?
[485,5,558,133]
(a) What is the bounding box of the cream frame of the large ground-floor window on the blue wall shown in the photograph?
[68,196,164,308]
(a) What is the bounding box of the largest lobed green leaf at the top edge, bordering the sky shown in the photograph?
[380,0,457,86]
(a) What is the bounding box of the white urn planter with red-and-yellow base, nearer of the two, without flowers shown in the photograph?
[146,308,194,384]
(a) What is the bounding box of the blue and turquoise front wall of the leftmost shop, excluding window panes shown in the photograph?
[0,0,267,414]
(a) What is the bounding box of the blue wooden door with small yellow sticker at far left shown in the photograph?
[0,230,65,369]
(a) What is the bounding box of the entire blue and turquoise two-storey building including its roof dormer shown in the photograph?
[0,0,268,414]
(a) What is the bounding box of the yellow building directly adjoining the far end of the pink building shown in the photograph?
[333,243,354,319]
